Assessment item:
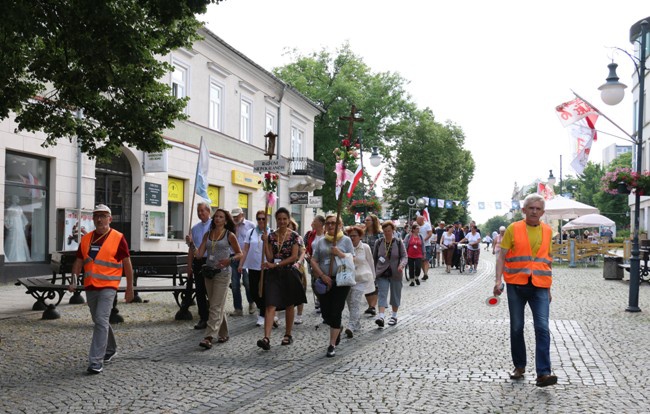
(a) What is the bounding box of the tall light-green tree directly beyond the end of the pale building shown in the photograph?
[273,43,414,211]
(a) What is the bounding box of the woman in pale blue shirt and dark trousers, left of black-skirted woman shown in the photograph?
[237,210,269,326]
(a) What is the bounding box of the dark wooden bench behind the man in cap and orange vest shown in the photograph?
[16,276,194,323]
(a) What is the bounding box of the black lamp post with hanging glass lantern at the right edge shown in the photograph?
[598,18,650,312]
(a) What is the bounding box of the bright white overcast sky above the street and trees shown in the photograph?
[201,0,650,223]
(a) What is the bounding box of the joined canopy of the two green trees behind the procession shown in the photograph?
[273,43,474,219]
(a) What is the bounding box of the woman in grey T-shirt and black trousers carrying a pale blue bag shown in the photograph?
[311,214,354,357]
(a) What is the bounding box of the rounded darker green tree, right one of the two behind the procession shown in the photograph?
[384,109,474,222]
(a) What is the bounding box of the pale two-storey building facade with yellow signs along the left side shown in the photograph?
[0,29,324,282]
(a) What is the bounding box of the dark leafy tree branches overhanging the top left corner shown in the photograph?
[0,0,220,158]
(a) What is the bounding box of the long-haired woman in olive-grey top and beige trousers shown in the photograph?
[190,208,242,349]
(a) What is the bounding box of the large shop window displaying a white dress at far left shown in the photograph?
[4,152,49,263]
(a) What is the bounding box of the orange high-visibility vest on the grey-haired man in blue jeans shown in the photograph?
[503,220,553,288]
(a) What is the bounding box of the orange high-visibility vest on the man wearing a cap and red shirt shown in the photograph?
[81,229,123,289]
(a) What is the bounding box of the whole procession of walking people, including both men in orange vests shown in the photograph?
[69,194,557,387]
